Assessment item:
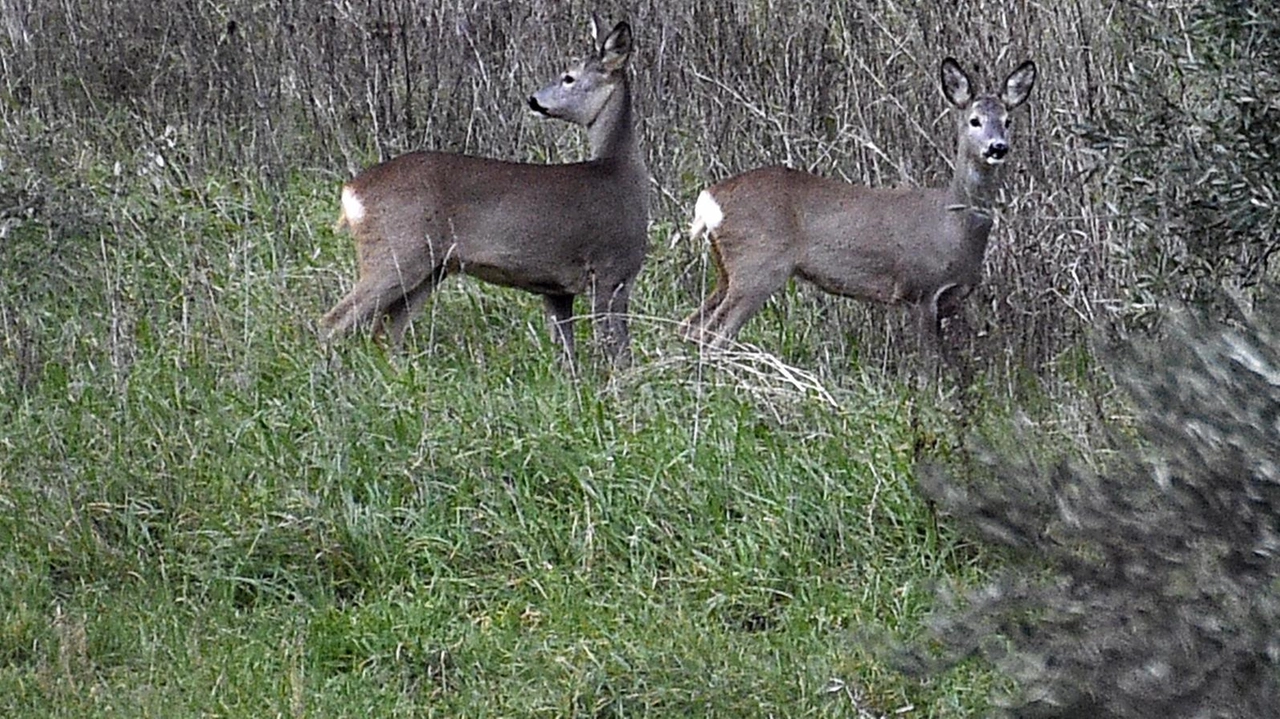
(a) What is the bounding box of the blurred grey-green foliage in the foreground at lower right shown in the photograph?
[908,300,1280,719]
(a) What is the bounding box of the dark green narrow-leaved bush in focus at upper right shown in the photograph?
[1093,0,1280,317]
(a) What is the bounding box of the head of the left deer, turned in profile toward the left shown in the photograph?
[529,18,631,127]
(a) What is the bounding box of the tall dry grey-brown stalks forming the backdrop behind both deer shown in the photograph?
[4,0,1146,366]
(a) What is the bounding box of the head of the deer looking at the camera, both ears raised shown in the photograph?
[942,58,1036,165]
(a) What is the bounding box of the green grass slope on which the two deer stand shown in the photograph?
[0,131,1080,718]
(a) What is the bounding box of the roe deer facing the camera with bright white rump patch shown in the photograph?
[681,58,1036,351]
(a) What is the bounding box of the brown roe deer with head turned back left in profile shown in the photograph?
[321,17,649,367]
